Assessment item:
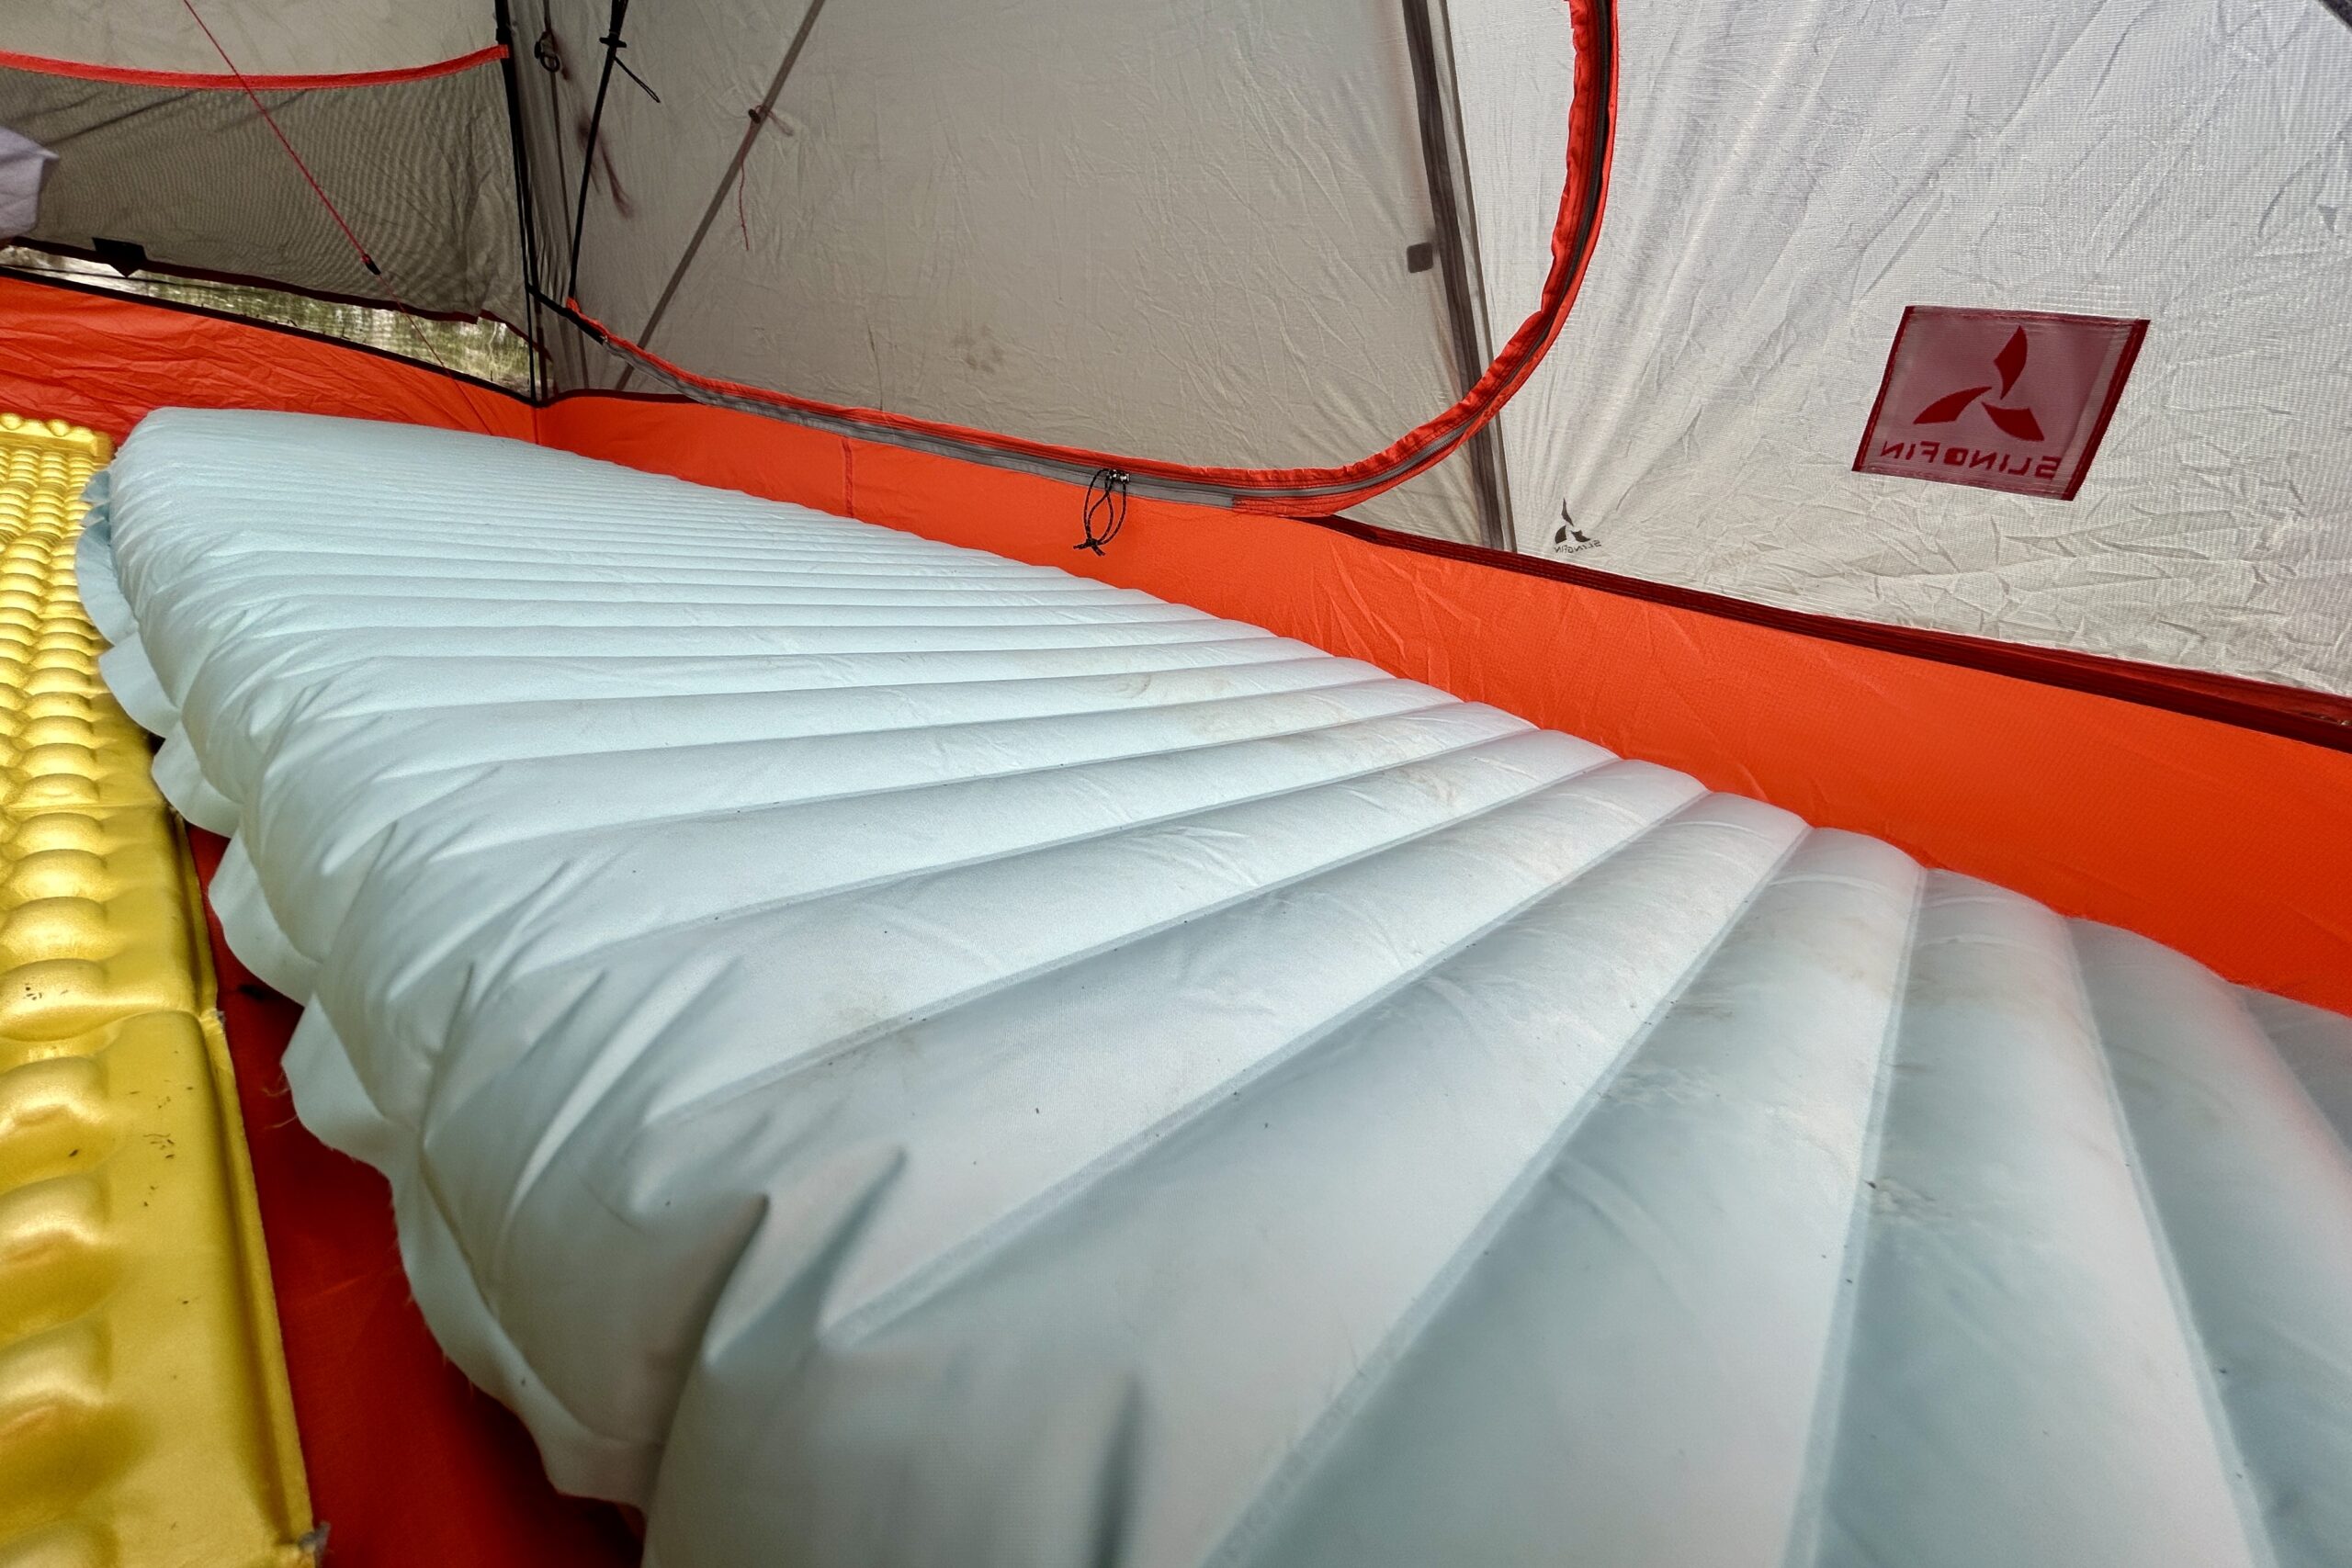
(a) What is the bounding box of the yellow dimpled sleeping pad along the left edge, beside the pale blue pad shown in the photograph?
[0,413,315,1568]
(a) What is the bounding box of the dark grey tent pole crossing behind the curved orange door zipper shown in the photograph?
[1404,0,1520,550]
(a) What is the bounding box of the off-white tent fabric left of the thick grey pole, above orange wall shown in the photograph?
[517,0,1486,538]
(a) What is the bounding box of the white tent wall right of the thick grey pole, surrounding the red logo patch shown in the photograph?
[1453,0,2352,691]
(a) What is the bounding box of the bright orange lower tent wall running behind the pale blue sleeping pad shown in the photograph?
[0,280,2352,1013]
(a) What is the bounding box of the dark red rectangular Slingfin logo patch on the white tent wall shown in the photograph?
[1853,306,2147,501]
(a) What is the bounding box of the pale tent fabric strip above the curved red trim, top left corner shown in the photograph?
[5,0,496,75]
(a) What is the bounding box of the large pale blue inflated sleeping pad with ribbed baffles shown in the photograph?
[101,412,2352,1568]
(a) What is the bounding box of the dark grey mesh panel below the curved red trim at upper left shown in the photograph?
[0,63,522,320]
